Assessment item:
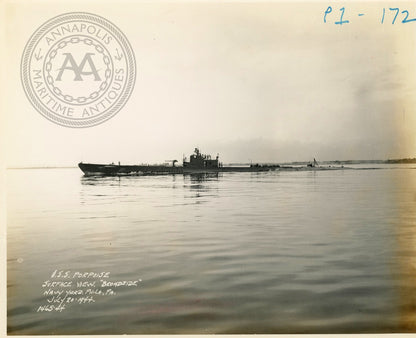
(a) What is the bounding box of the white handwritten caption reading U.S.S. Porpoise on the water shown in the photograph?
[36,270,142,312]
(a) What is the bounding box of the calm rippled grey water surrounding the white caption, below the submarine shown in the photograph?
[7,166,416,334]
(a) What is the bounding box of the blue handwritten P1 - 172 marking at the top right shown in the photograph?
[323,6,416,26]
